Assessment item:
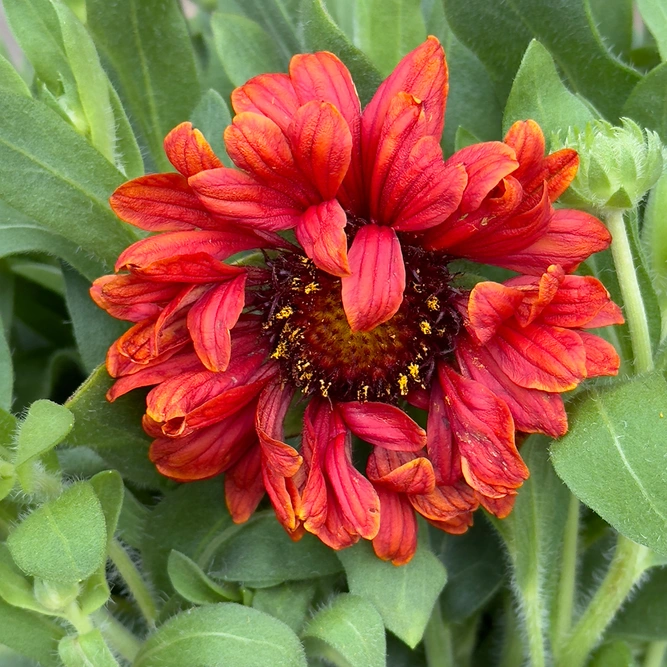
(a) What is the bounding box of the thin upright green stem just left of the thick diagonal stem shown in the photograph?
[553,494,579,655]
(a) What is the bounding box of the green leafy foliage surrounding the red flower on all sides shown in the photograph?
[0,0,667,667]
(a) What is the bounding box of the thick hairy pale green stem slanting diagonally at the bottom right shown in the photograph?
[558,535,651,667]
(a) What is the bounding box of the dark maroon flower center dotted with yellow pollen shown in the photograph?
[264,246,461,402]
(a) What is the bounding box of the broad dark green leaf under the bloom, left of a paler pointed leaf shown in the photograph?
[210,514,341,588]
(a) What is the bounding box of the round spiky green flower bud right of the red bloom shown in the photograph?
[554,118,663,214]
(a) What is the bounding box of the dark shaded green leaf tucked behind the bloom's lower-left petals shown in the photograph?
[63,366,166,489]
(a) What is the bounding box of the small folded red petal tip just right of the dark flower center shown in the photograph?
[468,282,524,343]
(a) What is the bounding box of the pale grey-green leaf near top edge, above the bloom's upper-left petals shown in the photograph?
[211,12,287,86]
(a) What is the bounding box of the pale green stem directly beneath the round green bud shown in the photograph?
[605,209,653,373]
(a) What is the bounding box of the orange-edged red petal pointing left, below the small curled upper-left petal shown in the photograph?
[109,174,215,232]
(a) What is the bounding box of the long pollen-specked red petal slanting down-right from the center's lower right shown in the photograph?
[438,364,528,498]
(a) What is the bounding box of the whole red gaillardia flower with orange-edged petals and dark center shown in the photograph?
[91,37,622,564]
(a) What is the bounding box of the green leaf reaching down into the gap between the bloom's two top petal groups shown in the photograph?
[300,0,382,105]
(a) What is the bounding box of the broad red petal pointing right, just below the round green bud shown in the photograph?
[494,208,611,276]
